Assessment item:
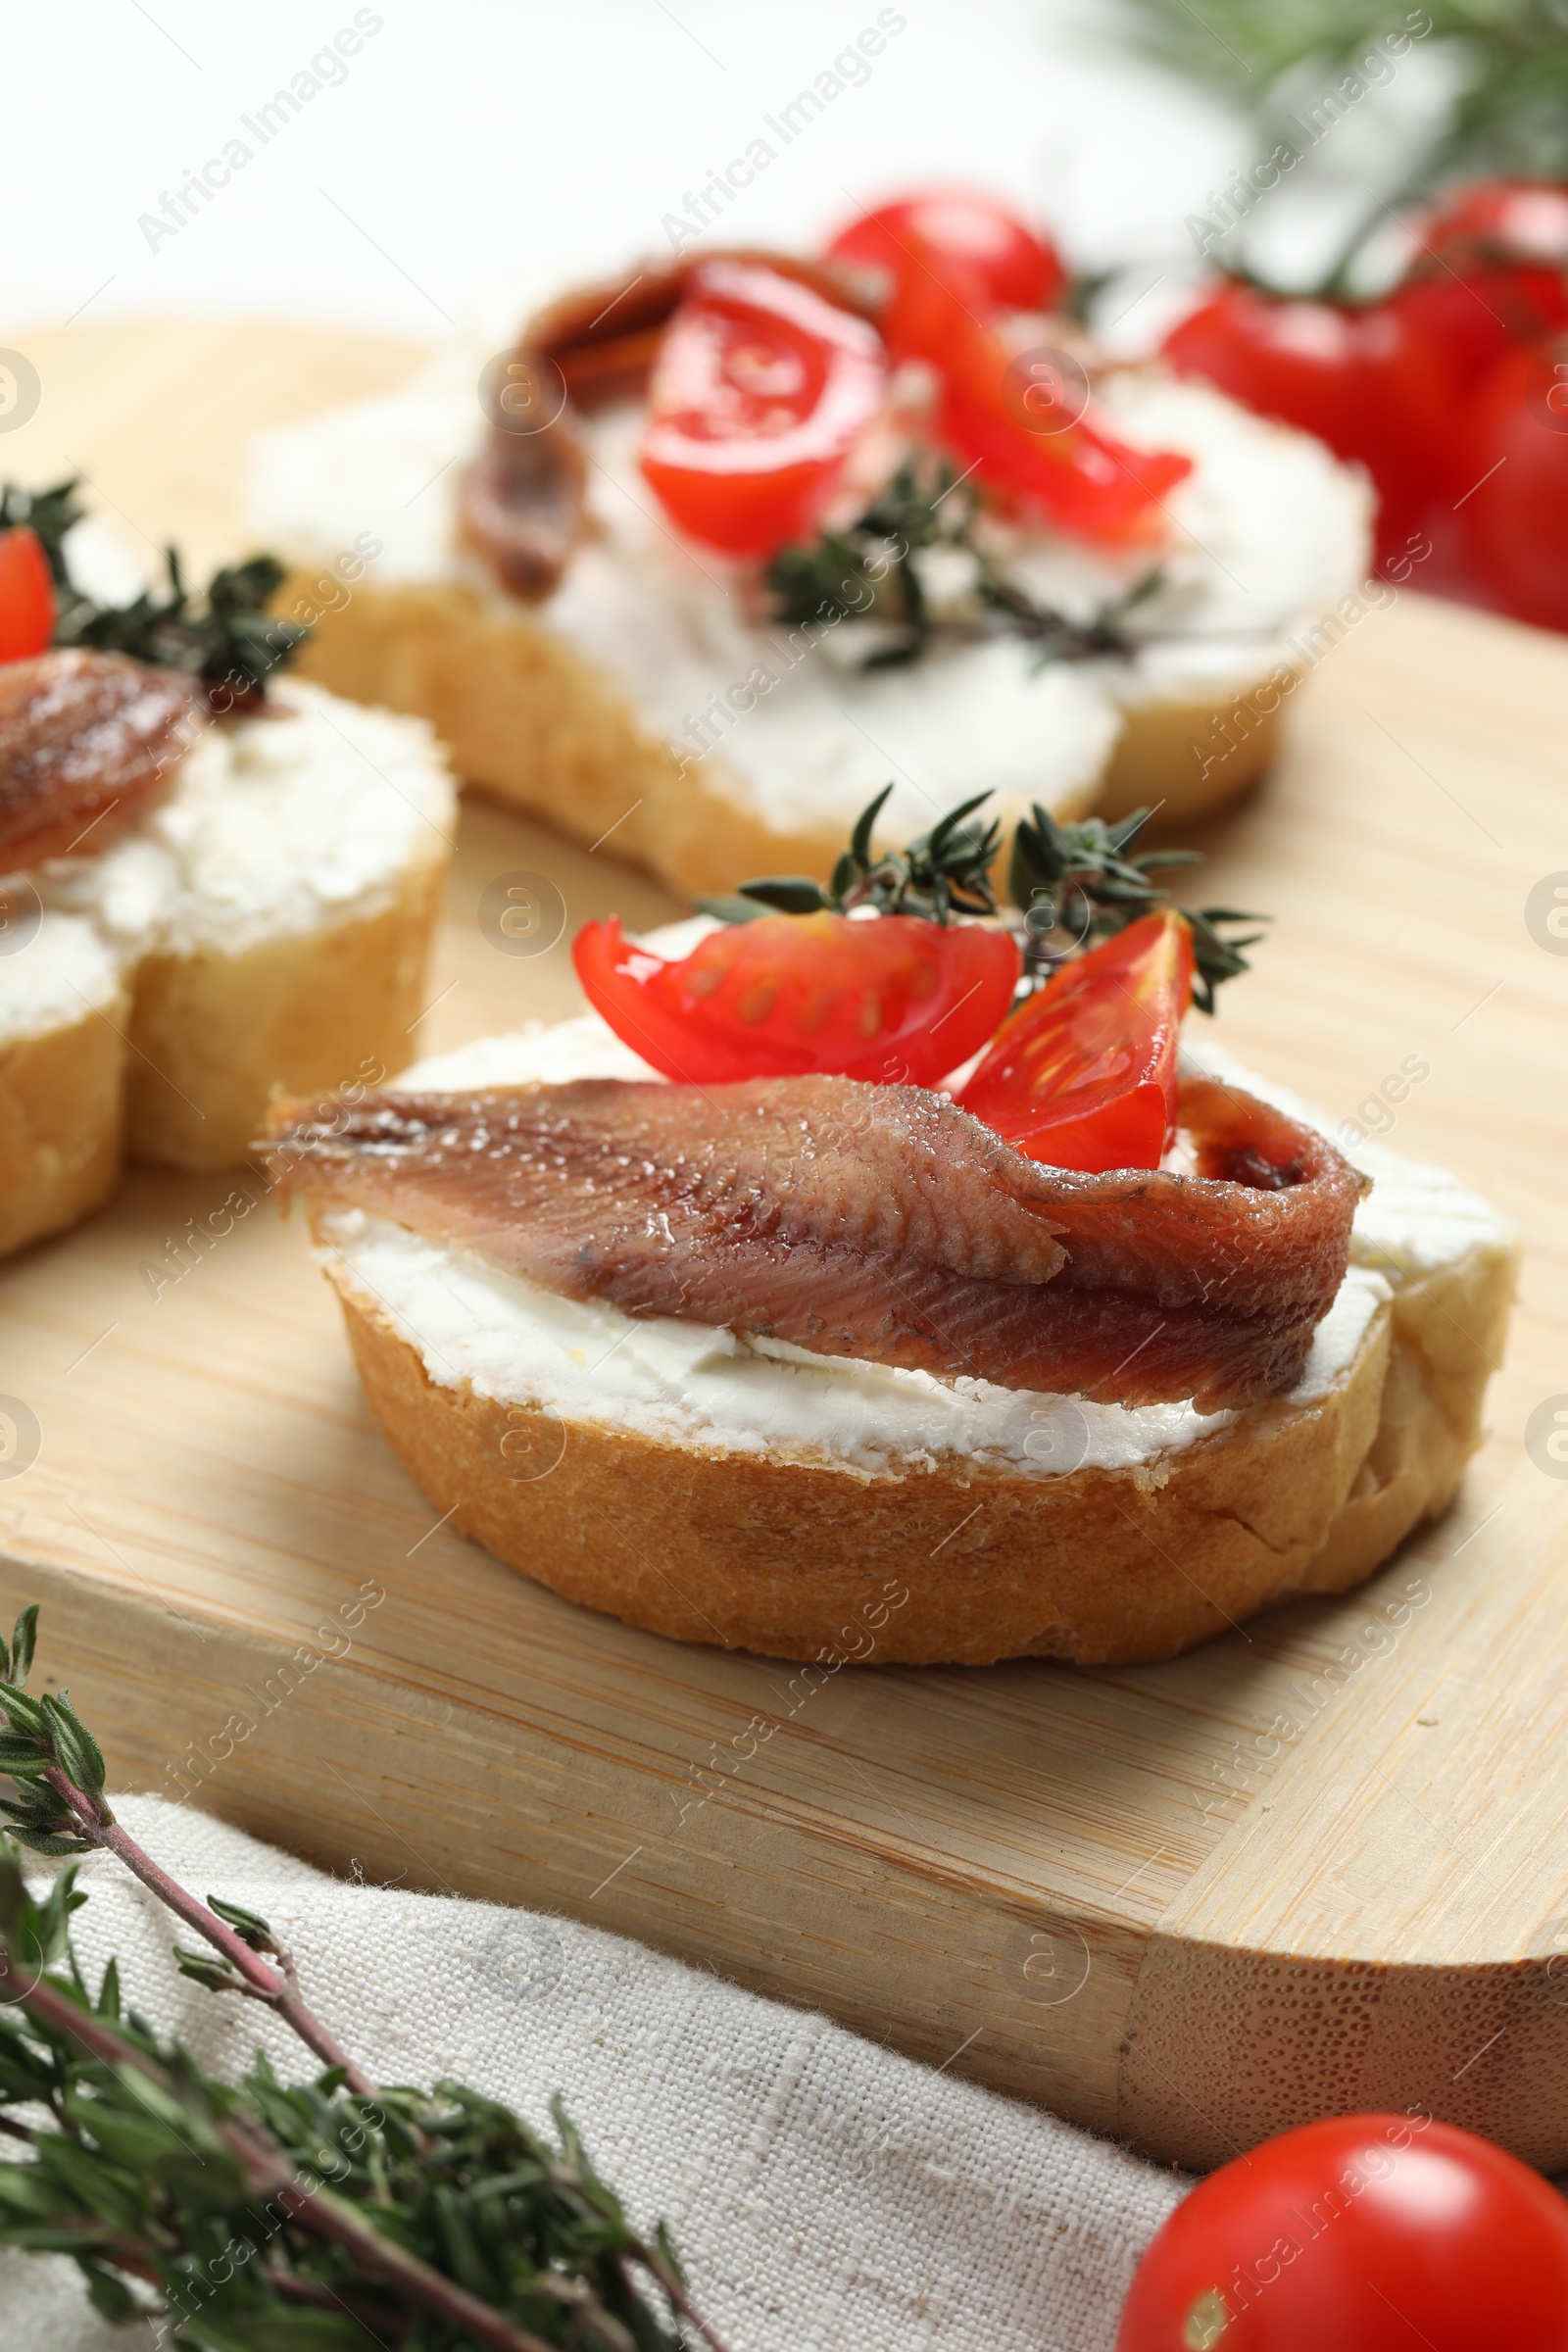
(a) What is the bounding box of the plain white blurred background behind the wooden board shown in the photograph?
[0,0,1249,336]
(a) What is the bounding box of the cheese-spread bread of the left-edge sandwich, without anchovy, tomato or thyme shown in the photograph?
[0,680,456,1251]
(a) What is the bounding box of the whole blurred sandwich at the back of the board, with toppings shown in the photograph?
[252,195,1371,896]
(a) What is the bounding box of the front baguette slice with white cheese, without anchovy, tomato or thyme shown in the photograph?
[287,973,1514,1665]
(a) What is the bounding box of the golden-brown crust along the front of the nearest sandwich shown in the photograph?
[338,1280,1422,1665]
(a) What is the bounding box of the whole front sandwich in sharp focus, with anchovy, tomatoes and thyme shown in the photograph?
[272,811,1514,1665]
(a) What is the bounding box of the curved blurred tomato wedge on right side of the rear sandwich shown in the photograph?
[884,247,1192,543]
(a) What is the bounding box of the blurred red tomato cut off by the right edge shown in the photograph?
[1460,336,1568,628]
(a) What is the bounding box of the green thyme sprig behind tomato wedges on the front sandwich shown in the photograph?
[698,783,1269,1013]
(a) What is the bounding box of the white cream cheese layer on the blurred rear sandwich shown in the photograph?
[249,301,1371,837]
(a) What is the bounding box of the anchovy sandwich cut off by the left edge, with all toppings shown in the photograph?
[0,484,454,1251]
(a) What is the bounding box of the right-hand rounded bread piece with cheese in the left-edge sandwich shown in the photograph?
[42,680,454,1169]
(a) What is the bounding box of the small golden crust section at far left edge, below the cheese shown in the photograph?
[0,995,129,1256]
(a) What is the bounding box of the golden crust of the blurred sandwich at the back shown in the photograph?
[277,571,1279,899]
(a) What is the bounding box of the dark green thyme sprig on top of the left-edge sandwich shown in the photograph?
[0,477,311,710]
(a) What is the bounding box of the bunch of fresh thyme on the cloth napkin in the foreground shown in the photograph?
[0,1606,724,2352]
